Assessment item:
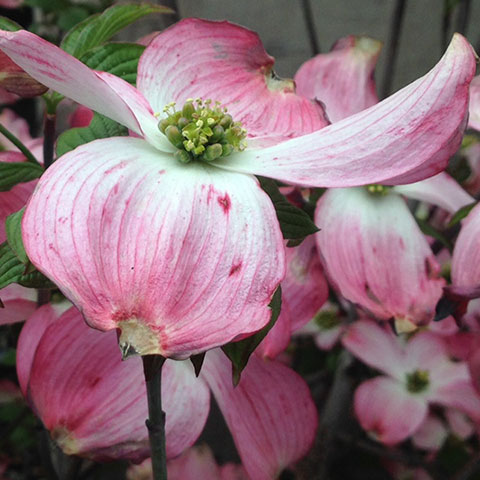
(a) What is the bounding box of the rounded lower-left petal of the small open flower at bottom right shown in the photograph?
[354,377,428,445]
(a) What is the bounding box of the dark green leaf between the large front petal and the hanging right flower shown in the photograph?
[258,177,319,240]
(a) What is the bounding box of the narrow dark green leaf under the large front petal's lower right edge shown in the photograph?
[222,285,282,385]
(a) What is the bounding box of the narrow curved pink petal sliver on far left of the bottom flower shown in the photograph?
[17,303,65,397]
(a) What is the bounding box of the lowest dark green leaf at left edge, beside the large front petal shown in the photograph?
[0,242,55,289]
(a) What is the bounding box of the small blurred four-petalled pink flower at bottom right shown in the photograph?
[342,320,480,445]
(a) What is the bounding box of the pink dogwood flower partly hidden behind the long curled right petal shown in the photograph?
[295,36,473,330]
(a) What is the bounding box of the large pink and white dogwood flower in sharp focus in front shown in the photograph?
[0,19,475,358]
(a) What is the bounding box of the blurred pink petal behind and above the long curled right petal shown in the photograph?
[295,35,382,122]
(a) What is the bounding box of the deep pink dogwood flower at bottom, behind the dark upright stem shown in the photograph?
[17,305,317,480]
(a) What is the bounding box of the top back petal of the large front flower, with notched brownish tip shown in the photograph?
[137,18,328,137]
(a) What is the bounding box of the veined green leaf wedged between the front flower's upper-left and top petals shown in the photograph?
[80,43,145,85]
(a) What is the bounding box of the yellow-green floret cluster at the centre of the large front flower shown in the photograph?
[158,98,247,163]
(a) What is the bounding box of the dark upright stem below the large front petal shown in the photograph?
[142,355,167,480]
